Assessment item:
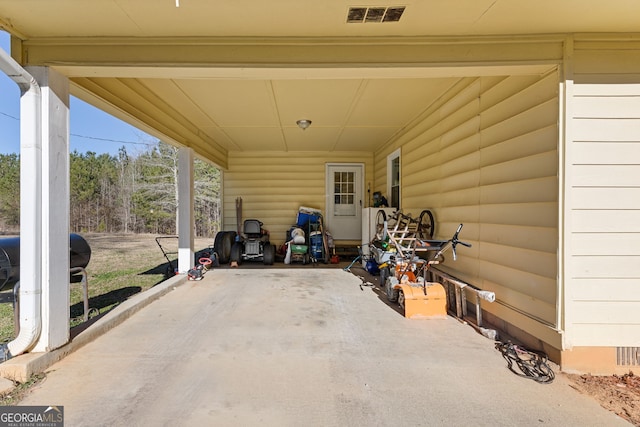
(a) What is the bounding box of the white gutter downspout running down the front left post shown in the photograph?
[0,49,42,362]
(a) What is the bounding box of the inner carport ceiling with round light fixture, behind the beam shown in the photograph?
[128,79,462,151]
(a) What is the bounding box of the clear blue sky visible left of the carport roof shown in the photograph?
[0,31,156,155]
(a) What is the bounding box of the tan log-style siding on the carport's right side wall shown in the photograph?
[376,71,561,348]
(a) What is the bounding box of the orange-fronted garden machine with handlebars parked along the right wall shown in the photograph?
[380,224,471,319]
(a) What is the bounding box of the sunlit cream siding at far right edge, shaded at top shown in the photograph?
[565,40,640,346]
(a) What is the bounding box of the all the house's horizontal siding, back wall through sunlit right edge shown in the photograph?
[218,38,640,362]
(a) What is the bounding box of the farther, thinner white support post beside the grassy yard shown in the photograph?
[177,147,195,274]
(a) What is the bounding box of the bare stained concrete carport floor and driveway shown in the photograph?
[21,267,629,426]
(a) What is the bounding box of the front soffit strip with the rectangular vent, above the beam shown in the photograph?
[0,0,640,38]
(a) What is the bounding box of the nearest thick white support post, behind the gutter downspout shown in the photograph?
[28,67,70,351]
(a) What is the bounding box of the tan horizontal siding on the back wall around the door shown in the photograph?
[223,151,373,245]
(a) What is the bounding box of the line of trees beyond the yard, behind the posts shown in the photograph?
[0,142,220,237]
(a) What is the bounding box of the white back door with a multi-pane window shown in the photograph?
[325,163,364,241]
